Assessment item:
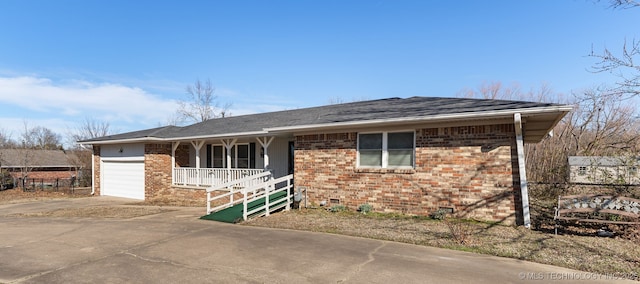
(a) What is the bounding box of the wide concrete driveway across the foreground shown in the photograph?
[0,197,637,283]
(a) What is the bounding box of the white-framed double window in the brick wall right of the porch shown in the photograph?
[358,131,415,168]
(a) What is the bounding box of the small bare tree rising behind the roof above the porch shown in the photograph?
[177,79,231,123]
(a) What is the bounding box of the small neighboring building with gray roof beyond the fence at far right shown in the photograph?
[569,156,640,185]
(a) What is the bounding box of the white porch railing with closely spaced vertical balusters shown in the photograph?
[173,168,264,186]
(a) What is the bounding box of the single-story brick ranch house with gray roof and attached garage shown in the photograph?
[80,97,571,226]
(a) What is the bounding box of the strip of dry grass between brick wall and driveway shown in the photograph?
[244,209,640,280]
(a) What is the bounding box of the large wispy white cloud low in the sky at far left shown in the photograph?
[0,76,176,124]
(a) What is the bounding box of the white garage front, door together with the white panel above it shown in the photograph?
[100,144,145,200]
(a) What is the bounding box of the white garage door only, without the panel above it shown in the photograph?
[102,161,144,200]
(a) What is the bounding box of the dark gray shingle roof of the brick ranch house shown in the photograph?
[80,97,564,144]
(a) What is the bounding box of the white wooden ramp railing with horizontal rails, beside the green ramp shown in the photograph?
[207,172,293,221]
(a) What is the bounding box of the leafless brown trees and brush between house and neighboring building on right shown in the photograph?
[526,89,640,183]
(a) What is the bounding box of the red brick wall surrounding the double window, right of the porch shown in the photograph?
[295,124,519,223]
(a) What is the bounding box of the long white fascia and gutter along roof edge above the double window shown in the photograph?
[265,105,573,133]
